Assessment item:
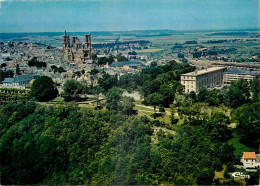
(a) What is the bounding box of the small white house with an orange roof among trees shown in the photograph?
[241,152,260,170]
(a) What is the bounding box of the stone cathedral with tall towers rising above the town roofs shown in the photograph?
[63,30,94,64]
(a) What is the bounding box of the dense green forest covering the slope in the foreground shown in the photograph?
[0,101,259,185]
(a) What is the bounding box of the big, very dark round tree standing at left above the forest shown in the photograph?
[31,76,58,101]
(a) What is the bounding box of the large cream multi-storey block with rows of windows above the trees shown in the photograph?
[181,67,226,93]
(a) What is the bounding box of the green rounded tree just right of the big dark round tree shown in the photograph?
[62,79,83,101]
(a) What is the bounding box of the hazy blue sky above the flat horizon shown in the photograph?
[0,0,260,33]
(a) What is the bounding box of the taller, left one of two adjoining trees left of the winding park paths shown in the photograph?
[106,87,123,111]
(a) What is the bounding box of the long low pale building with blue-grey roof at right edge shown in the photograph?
[223,69,260,85]
